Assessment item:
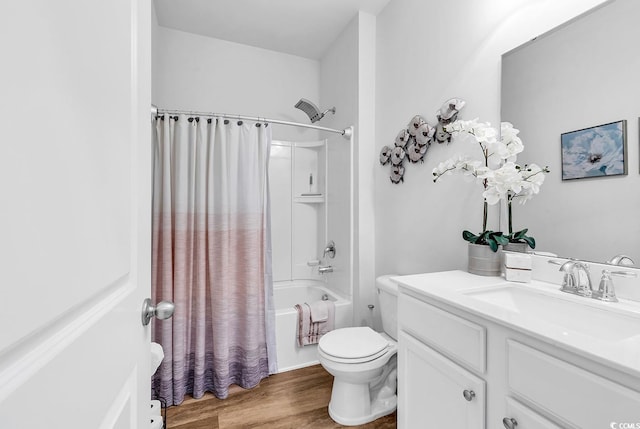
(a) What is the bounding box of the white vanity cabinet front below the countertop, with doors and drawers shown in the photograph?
[398,286,640,429]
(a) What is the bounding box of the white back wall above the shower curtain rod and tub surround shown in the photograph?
[152,24,320,140]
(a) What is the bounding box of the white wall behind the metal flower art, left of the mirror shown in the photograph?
[375,0,602,274]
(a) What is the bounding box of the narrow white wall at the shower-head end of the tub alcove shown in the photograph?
[320,12,376,325]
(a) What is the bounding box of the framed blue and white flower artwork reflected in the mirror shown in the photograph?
[560,121,627,180]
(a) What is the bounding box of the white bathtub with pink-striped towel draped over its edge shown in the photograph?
[273,280,353,372]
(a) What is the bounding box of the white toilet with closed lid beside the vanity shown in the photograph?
[318,276,398,426]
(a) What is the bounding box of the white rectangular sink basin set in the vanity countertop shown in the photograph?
[464,283,640,342]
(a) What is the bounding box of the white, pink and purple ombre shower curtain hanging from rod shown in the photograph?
[152,115,277,405]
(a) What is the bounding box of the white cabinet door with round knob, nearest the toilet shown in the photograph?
[398,331,485,429]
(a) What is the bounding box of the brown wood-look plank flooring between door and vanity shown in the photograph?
[167,365,396,429]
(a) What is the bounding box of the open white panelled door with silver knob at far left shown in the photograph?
[0,0,151,429]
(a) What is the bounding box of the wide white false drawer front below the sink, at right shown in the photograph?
[507,340,640,429]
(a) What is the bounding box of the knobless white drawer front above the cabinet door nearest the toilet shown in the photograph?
[398,294,486,374]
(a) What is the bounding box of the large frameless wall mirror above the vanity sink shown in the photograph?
[501,0,640,266]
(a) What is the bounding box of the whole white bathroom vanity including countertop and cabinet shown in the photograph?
[395,267,640,429]
